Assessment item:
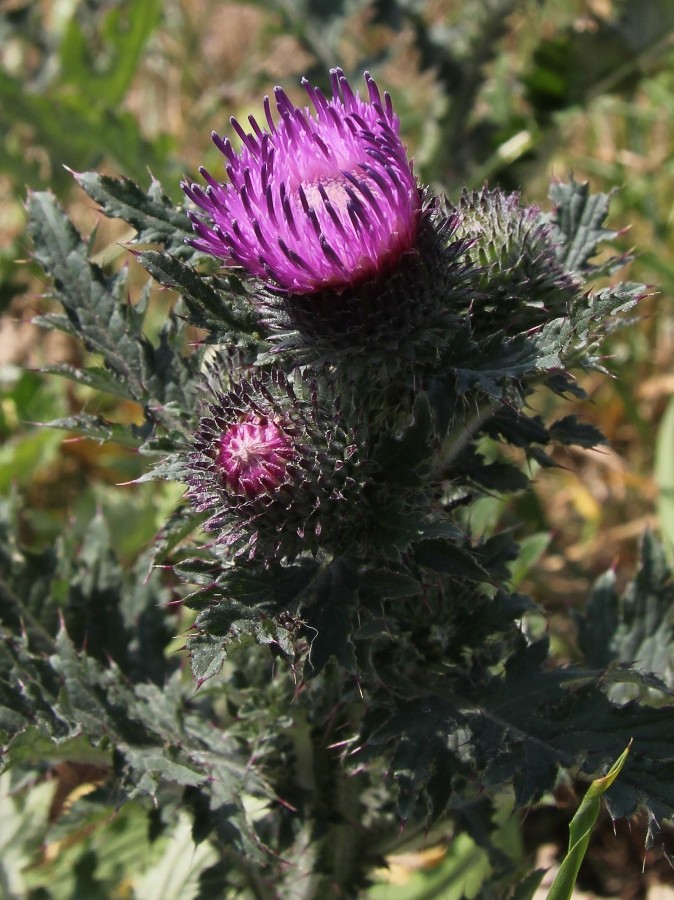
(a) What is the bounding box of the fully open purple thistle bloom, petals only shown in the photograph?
[182,69,421,294]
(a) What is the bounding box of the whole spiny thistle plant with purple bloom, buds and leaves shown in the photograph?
[6,69,674,898]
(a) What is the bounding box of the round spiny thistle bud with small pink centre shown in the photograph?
[186,372,363,561]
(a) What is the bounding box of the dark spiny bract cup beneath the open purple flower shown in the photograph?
[257,194,474,366]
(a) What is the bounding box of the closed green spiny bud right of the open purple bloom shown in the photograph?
[455,188,580,333]
